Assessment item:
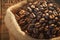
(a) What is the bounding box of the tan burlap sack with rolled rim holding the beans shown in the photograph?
[4,1,60,40]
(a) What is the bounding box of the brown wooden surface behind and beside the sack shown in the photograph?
[0,0,60,40]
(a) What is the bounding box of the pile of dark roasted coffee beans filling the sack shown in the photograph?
[15,1,60,39]
